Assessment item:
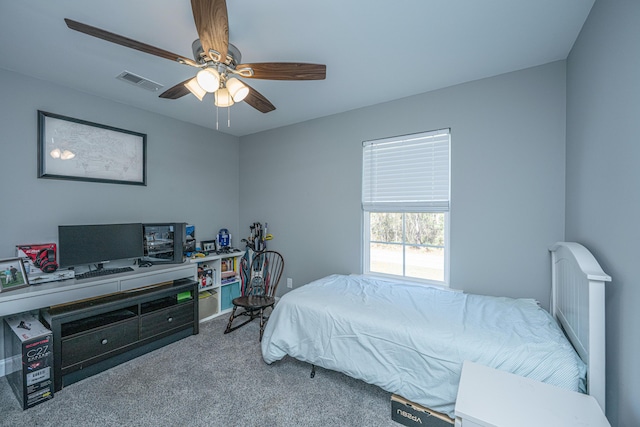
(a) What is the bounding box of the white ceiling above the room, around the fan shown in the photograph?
[0,0,594,136]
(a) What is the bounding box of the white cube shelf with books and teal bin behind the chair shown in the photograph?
[190,251,244,322]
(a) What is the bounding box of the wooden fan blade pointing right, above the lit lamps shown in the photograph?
[236,62,327,80]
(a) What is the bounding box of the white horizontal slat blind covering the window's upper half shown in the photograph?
[362,129,450,212]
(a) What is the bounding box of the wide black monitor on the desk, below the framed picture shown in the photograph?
[58,223,144,268]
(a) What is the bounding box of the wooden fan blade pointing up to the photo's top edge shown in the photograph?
[191,0,229,62]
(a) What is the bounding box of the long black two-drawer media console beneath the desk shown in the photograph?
[40,277,199,391]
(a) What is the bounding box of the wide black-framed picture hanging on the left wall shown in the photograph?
[38,110,147,185]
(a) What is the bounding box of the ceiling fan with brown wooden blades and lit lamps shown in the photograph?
[65,0,326,113]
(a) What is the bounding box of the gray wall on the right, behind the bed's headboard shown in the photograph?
[566,0,640,427]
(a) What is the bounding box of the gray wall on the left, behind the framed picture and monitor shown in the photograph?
[0,69,239,376]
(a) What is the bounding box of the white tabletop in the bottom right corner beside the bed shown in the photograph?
[455,361,610,427]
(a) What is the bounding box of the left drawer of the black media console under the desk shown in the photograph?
[61,318,138,369]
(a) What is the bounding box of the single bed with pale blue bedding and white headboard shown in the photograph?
[261,242,611,418]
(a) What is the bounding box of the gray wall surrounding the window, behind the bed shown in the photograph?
[240,61,566,306]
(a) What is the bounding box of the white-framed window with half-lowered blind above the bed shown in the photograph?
[362,129,451,284]
